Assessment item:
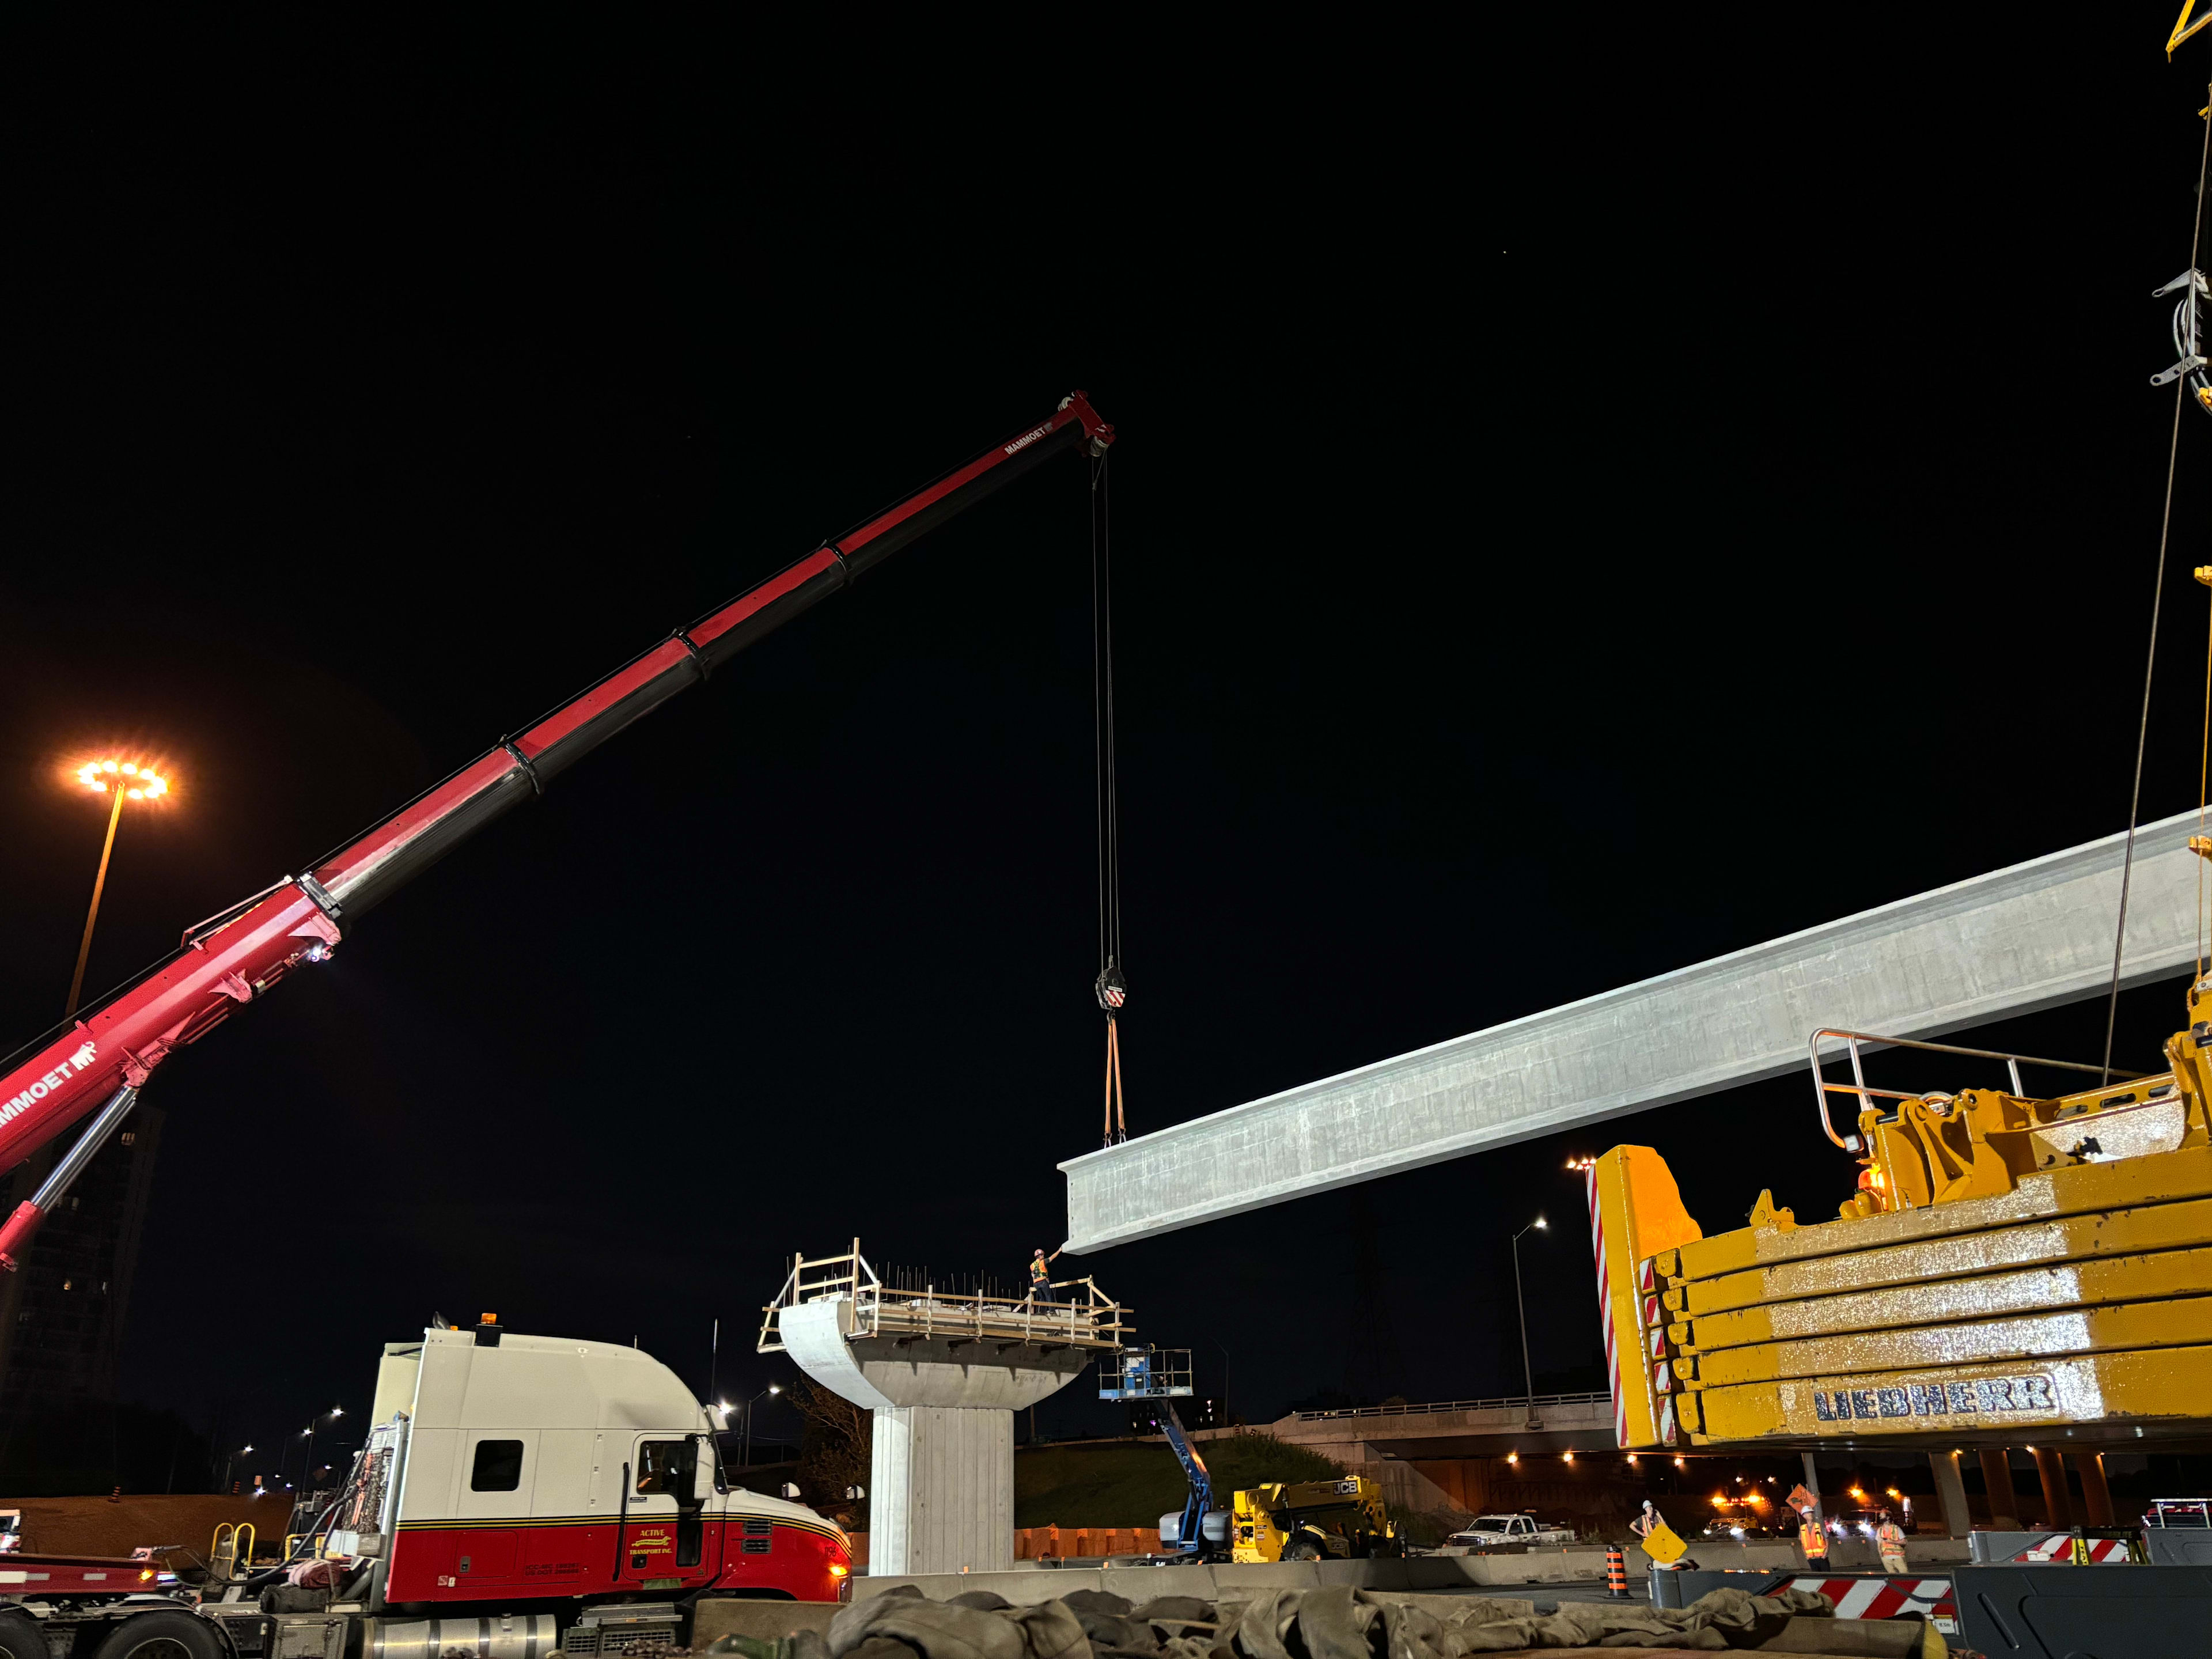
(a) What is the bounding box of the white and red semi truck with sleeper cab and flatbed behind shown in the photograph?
[0,1314,851,1659]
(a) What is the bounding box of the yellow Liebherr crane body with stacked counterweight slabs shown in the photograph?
[1588,995,2212,1449]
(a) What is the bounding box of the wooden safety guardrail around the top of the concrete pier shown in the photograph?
[759,1238,1130,1354]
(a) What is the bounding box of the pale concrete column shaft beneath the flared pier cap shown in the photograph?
[867,1404,1013,1573]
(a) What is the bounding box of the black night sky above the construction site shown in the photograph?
[0,19,2212,1486]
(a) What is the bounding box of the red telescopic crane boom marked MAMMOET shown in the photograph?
[0,392,1113,1270]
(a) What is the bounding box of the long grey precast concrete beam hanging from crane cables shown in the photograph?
[1059,814,2196,1252]
